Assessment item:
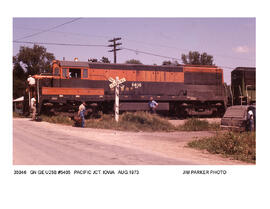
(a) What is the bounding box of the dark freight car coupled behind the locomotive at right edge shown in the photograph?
[231,67,256,105]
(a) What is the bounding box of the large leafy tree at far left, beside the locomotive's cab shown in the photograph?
[13,45,55,98]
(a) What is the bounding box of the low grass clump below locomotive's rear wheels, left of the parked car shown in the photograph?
[177,118,220,131]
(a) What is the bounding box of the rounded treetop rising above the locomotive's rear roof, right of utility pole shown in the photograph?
[181,51,214,65]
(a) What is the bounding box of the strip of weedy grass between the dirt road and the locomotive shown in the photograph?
[39,112,219,132]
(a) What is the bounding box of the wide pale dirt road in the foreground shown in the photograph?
[13,118,245,165]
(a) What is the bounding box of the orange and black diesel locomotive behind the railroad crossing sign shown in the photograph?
[25,60,227,117]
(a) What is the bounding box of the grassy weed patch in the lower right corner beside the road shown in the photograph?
[188,132,256,163]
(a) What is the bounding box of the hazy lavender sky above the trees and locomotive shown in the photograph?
[13,18,256,84]
